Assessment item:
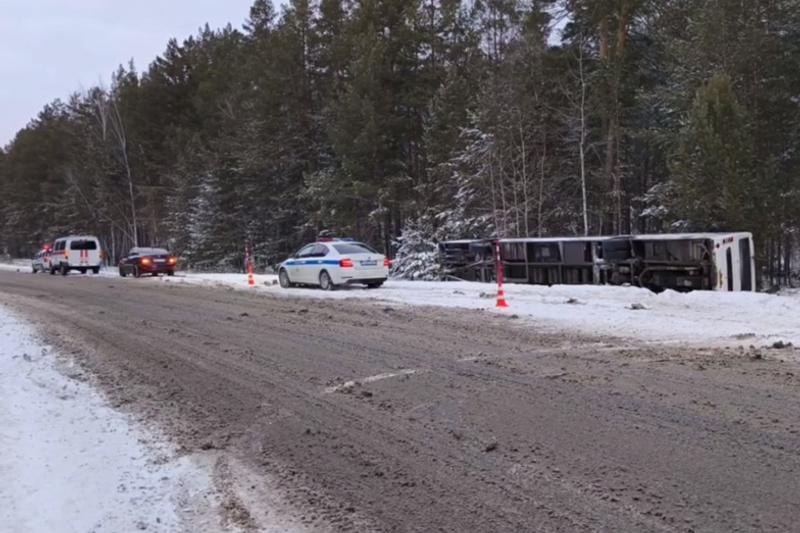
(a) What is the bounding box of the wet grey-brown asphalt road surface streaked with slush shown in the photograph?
[0,272,800,532]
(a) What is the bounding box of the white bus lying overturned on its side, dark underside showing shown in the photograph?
[439,232,755,291]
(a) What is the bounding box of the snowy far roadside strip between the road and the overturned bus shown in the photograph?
[1,260,800,352]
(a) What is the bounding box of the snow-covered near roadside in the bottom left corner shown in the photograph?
[0,307,241,533]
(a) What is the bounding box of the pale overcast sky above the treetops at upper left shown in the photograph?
[0,0,279,146]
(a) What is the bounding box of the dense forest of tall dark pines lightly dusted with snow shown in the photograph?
[0,0,800,281]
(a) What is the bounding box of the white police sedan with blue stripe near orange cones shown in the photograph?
[278,239,390,291]
